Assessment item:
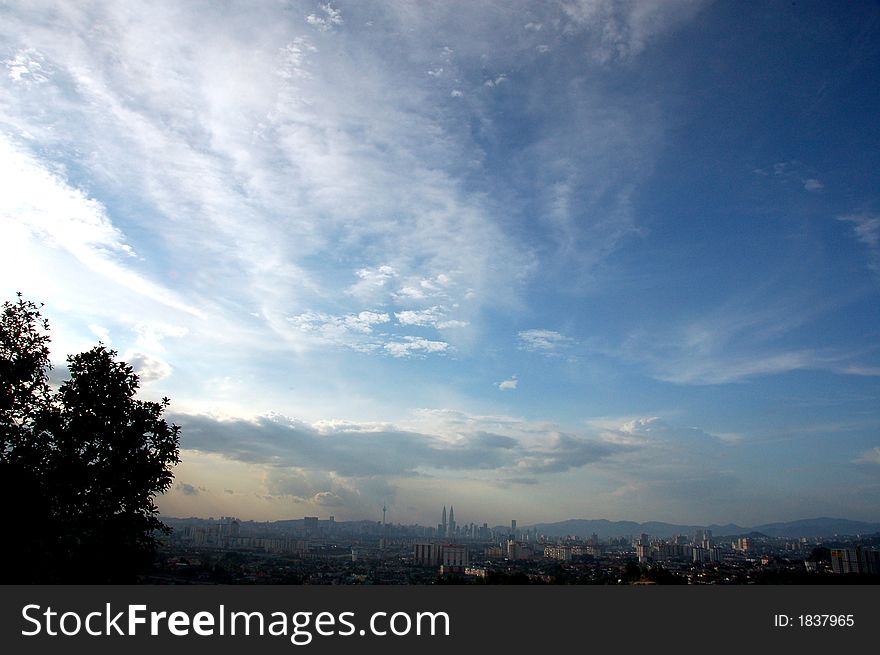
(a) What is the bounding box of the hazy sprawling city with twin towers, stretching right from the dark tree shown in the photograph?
[158,506,880,584]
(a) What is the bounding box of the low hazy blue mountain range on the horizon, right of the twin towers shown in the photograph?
[529,517,880,539]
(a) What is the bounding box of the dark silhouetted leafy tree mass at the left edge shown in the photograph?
[0,295,180,583]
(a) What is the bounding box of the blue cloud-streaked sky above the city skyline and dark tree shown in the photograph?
[0,0,880,526]
